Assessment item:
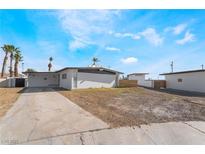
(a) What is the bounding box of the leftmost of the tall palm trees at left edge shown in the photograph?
[1,44,13,77]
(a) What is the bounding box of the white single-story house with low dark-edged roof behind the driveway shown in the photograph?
[24,67,122,90]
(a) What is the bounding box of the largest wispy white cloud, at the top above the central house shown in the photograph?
[58,10,120,50]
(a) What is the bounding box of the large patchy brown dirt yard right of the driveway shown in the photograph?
[58,87,205,127]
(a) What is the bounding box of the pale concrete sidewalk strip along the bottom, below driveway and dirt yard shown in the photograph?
[24,122,205,145]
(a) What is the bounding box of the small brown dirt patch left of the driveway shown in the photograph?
[0,88,22,117]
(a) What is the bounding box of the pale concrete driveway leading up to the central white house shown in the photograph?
[0,88,108,144]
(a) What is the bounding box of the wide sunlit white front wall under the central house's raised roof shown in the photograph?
[77,72,118,89]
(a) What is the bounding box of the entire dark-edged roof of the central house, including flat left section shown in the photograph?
[23,67,123,74]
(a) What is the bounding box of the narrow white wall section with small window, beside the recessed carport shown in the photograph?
[59,70,77,89]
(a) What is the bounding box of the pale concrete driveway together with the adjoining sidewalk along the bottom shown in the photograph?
[0,88,205,144]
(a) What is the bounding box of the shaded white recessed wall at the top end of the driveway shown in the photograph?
[27,73,58,87]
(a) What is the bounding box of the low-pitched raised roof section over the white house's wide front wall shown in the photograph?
[56,67,124,74]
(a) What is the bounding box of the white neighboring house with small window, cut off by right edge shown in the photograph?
[160,70,205,92]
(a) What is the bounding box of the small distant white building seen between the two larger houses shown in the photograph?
[127,73,154,88]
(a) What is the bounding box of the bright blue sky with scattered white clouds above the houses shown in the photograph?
[0,10,205,78]
